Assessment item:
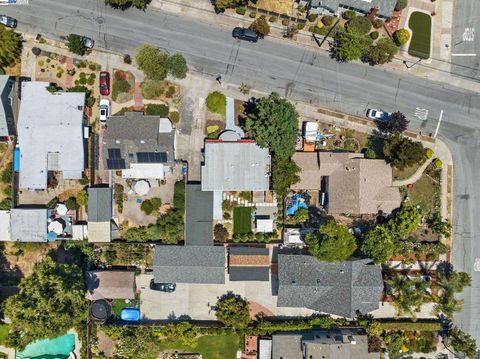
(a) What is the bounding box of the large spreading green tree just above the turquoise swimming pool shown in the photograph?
[4,257,87,350]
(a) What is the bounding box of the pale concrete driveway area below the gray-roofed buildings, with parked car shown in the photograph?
[137,274,314,320]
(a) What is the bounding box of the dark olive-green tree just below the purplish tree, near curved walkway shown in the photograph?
[383,134,425,170]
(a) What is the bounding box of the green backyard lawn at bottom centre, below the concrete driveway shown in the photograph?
[159,334,240,359]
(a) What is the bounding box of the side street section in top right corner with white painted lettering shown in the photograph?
[451,0,480,80]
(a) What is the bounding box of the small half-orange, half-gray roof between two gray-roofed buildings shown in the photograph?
[228,247,270,282]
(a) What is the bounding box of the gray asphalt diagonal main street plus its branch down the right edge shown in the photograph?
[1,0,480,343]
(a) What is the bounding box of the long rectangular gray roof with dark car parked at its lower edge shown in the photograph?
[153,245,225,284]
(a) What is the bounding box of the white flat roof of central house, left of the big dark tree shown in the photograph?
[202,140,270,191]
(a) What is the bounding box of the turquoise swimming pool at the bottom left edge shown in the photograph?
[17,334,75,359]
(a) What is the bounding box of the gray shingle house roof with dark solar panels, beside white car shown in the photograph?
[102,112,175,168]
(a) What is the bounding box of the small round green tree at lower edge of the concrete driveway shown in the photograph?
[215,292,251,329]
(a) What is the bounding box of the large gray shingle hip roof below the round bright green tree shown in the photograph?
[277,254,383,318]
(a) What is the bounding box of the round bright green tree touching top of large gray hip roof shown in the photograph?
[305,221,357,262]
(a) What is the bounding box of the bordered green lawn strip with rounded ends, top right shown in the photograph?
[408,11,432,59]
